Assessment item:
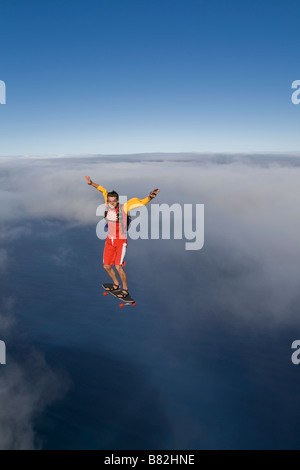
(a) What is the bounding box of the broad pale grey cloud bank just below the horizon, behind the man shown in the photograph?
[0,154,300,328]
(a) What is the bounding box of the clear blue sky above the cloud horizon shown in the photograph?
[0,0,300,155]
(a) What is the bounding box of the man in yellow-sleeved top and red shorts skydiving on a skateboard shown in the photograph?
[85,176,159,300]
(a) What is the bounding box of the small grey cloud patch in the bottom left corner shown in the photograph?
[0,348,67,450]
